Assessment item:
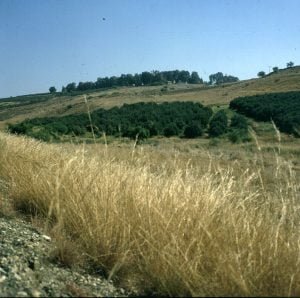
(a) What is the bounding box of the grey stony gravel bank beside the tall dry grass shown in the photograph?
[0,213,128,297]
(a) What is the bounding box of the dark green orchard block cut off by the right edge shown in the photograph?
[230,91,300,136]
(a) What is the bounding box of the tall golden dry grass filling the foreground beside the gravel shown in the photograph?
[0,134,300,296]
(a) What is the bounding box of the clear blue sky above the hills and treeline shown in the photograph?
[0,0,300,97]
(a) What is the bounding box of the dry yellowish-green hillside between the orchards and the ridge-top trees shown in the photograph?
[0,66,300,129]
